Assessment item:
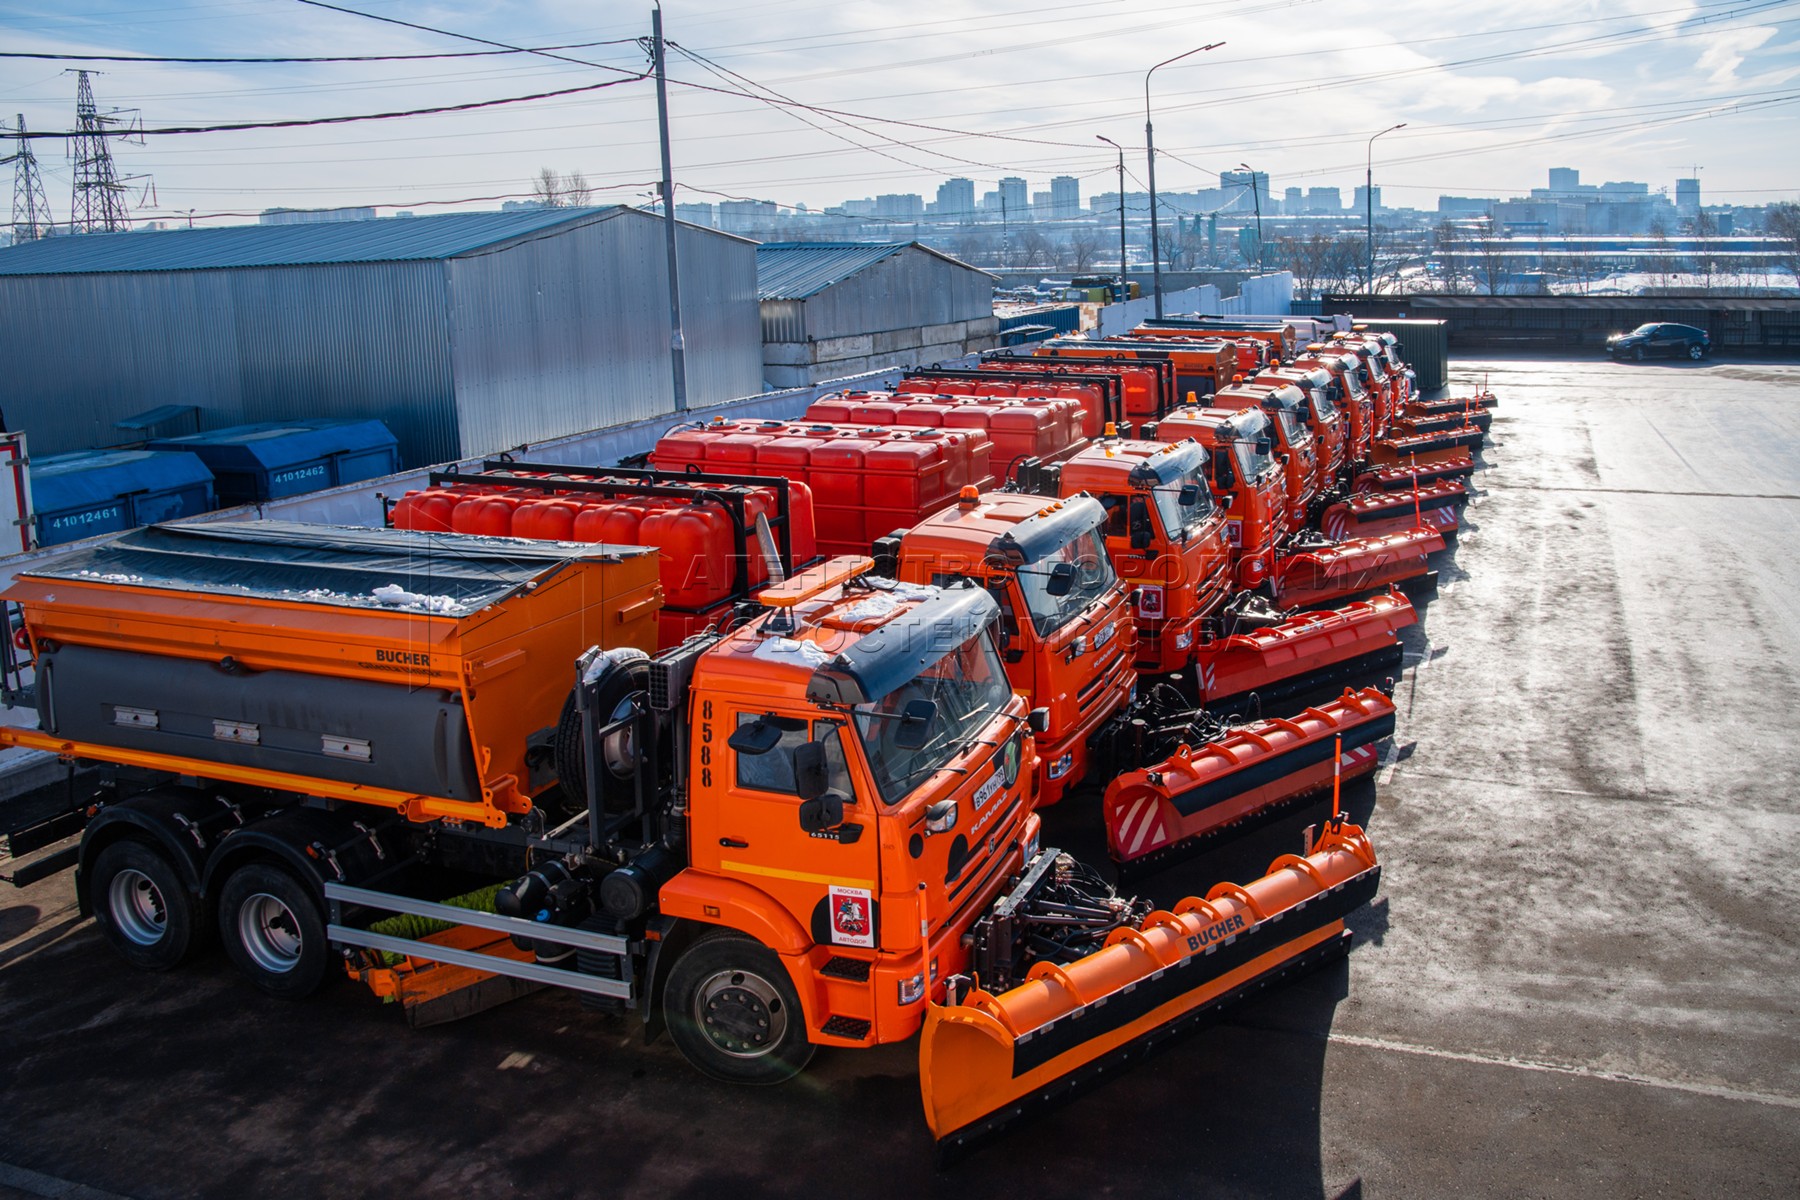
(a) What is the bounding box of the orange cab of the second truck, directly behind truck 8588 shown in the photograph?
[877,489,1138,808]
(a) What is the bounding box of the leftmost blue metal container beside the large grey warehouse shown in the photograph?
[31,450,216,545]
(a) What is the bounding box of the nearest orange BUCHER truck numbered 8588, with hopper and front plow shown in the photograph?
[0,522,1379,1150]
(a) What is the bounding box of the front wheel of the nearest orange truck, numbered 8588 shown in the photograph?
[662,932,814,1083]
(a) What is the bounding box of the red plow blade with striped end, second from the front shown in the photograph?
[1105,687,1393,878]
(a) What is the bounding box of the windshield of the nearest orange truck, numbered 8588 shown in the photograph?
[855,630,1012,804]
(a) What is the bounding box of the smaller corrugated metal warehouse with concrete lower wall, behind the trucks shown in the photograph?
[756,241,999,387]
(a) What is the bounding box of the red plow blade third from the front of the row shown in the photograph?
[1193,590,1418,712]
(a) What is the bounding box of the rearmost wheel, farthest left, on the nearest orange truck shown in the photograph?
[86,840,207,972]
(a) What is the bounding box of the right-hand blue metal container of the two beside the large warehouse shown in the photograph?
[146,419,400,507]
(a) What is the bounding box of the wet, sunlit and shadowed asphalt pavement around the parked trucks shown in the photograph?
[0,356,1800,1198]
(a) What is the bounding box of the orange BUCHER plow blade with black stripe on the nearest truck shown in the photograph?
[918,820,1381,1157]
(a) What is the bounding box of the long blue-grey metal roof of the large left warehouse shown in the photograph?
[0,207,634,275]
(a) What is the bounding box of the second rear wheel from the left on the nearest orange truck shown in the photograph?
[220,862,331,1000]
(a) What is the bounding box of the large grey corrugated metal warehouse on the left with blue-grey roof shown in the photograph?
[0,207,763,466]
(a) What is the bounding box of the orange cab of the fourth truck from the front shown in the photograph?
[1147,405,1287,590]
